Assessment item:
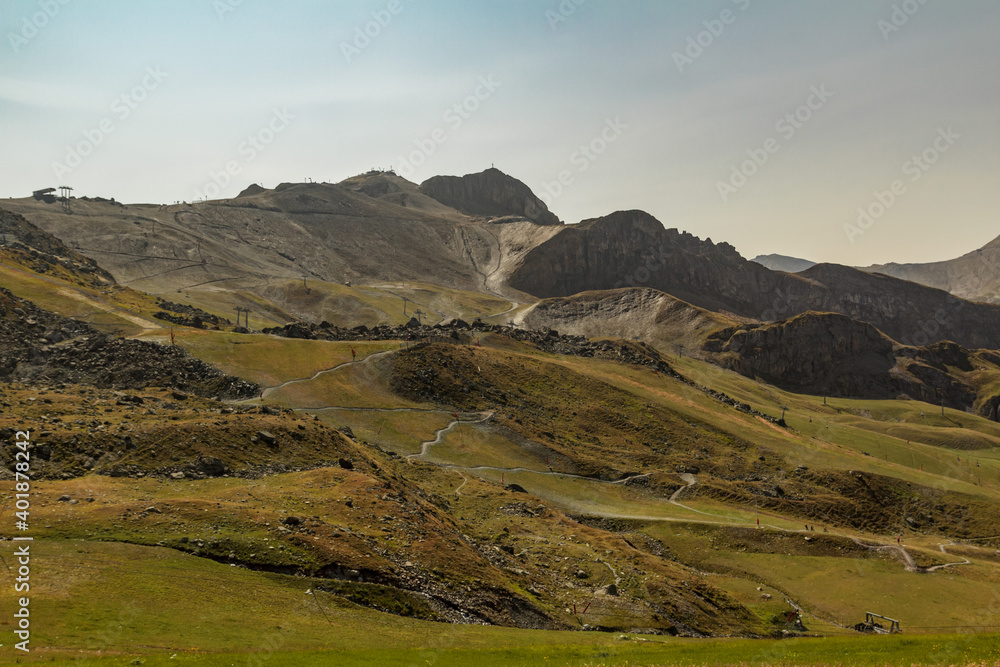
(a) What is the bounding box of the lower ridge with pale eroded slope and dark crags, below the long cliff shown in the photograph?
[518,288,1000,421]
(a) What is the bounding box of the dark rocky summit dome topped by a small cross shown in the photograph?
[420,168,561,225]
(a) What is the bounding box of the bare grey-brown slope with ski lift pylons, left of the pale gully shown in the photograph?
[4,175,500,293]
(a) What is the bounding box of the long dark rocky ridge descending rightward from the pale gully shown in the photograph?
[510,211,1000,349]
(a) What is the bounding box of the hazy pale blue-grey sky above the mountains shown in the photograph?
[0,0,1000,266]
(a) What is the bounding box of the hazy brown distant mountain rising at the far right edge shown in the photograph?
[863,236,1000,303]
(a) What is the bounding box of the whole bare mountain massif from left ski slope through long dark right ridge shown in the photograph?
[5,175,1000,349]
